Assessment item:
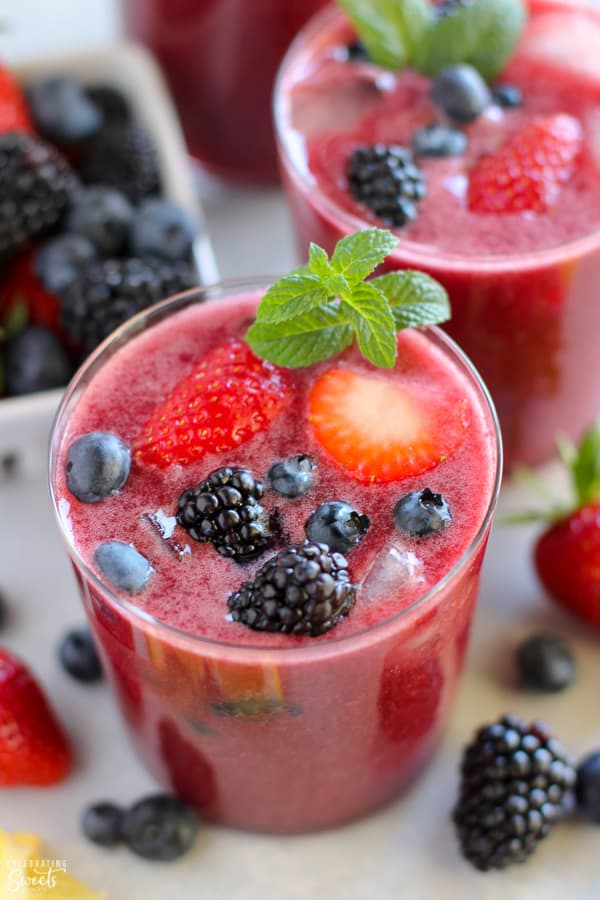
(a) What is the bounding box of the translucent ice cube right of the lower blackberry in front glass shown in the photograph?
[359,544,425,603]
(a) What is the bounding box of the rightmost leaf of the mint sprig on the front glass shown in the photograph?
[371,274,450,331]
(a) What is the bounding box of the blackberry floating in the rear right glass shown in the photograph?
[347,144,427,228]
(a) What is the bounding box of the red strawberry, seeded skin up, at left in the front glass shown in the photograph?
[134,340,290,468]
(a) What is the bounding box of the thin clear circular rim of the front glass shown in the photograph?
[48,276,503,659]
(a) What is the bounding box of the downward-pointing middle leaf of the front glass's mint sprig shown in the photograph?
[341,284,397,369]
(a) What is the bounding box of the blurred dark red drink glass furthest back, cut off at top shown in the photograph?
[121,0,325,182]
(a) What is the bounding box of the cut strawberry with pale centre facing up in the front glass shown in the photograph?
[308,367,469,482]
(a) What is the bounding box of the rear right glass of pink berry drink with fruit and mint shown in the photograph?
[276,0,600,467]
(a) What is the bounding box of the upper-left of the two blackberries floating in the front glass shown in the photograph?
[177,466,272,562]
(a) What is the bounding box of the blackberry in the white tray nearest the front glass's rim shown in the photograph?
[60,257,198,353]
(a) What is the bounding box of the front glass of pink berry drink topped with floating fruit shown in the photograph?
[50,279,500,833]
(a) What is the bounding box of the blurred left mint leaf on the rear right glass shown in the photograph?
[338,0,433,69]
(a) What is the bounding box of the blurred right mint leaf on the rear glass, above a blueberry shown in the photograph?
[414,0,525,81]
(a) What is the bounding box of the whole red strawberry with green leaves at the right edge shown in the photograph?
[534,424,600,629]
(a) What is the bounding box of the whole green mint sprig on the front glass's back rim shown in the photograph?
[246,228,450,369]
